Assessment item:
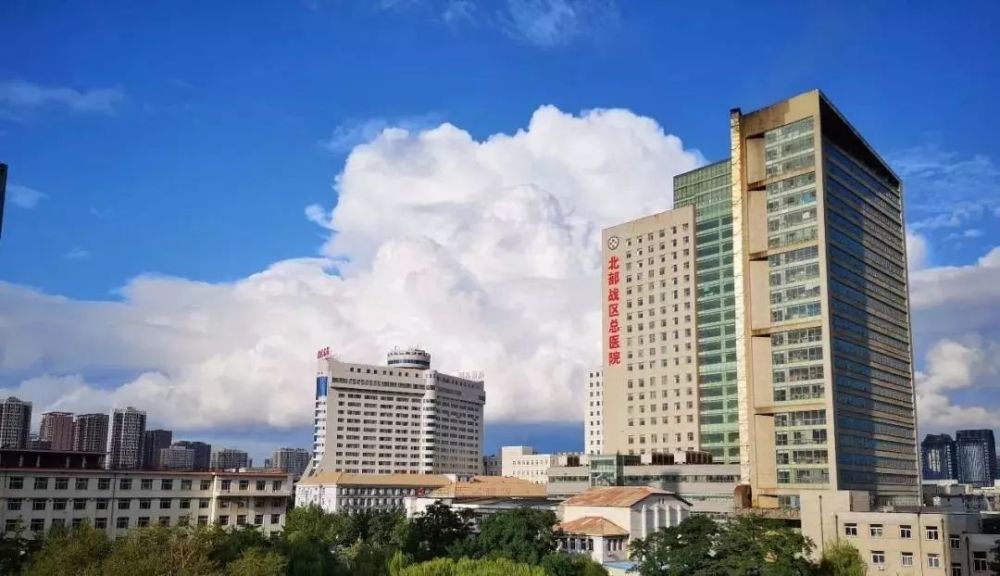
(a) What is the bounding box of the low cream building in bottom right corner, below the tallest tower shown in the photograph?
[801,491,1000,576]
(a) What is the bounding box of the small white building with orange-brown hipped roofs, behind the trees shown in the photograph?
[559,486,691,564]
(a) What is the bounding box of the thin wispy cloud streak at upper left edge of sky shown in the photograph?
[0,80,125,115]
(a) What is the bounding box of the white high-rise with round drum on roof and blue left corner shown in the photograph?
[310,349,486,475]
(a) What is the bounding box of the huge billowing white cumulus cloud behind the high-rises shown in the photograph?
[0,106,704,430]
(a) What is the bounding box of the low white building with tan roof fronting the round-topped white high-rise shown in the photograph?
[295,472,455,513]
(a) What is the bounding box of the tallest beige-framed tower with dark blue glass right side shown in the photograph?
[730,91,920,507]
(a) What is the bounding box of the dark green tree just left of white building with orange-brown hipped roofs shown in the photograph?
[464,508,558,565]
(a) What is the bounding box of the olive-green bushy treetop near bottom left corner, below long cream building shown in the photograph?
[24,524,111,576]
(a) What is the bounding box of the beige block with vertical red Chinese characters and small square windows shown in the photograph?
[601,206,699,454]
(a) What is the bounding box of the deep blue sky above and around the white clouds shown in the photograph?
[0,0,1000,460]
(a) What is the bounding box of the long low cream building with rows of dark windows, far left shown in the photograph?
[0,468,292,538]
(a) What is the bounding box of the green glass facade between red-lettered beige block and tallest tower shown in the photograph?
[674,159,740,463]
